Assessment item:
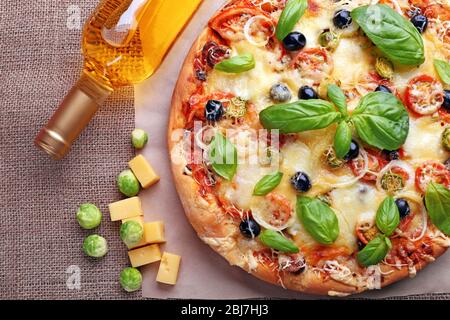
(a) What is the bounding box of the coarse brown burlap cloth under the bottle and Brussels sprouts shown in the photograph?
[0,0,450,299]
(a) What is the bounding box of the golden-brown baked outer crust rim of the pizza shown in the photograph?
[168,1,447,296]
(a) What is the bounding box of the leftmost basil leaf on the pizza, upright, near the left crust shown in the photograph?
[209,133,237,180]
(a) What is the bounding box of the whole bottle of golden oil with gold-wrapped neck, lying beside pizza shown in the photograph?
[35,0,202,159]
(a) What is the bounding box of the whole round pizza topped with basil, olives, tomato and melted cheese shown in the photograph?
[168,0,450,296]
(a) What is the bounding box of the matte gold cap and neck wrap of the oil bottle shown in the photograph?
[34,74,112,160]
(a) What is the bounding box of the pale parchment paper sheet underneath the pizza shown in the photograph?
[135,0,450,299]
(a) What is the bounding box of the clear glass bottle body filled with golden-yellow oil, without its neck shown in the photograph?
[82,0,202,88]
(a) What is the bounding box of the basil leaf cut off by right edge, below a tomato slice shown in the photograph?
[425,182,450,236]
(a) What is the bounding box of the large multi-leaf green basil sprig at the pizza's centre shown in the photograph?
[259,92,409,151]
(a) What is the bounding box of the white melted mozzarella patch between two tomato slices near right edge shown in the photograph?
[403,117,448,164]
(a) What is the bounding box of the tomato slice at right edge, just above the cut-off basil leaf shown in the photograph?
[416,160,450,193]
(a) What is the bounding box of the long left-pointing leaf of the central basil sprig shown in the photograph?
[259,99,341,133]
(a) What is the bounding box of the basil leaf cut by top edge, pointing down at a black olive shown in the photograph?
[275,0,308,41]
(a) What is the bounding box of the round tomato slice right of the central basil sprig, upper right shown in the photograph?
[404,75,444,115]
